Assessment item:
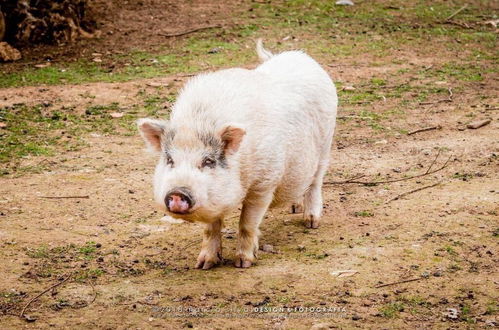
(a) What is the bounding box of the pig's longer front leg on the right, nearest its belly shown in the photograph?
[234,192,273,268]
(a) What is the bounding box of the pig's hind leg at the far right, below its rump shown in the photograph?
[303,158,329,229]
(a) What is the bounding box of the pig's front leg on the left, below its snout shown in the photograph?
[196,220,222,269]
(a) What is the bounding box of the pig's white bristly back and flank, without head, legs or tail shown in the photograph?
[171,58,337,204]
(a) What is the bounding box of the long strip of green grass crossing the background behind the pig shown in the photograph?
[0,0,497,88]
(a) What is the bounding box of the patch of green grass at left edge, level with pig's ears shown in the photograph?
[0,103,137,176]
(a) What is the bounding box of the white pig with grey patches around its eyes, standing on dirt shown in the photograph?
[137,40,338,269]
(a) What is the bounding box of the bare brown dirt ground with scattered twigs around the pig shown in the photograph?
[0,1,499,329]
